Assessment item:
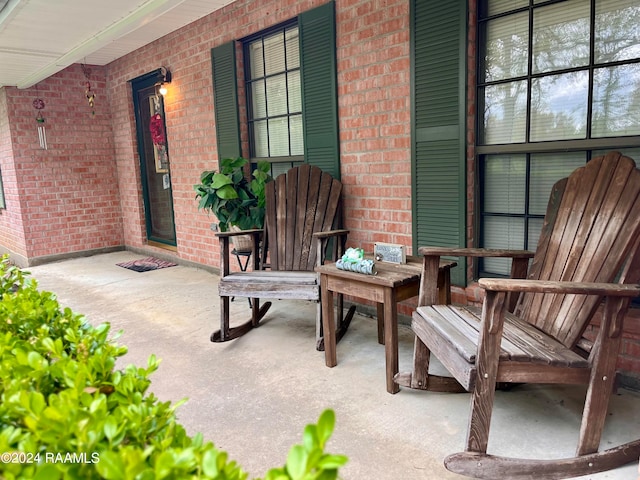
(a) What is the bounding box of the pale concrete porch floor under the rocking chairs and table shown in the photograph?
[27,251,640,480]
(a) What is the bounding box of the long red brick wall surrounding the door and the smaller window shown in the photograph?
[107,0,411,267]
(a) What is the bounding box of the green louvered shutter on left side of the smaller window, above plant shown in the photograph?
[211,41,242,160]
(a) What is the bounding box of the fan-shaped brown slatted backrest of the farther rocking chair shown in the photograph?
[263,164,342,271]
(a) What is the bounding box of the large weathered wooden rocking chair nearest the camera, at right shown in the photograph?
[396,152,640,479]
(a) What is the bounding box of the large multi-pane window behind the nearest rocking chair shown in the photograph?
[477,0,640,275]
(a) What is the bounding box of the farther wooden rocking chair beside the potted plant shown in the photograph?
[211,164,355,350]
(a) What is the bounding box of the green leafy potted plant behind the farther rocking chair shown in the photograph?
[193,157,273,232]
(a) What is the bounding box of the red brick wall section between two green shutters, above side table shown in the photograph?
[336,0,412,250]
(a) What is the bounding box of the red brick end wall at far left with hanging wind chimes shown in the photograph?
[0,65,123,264]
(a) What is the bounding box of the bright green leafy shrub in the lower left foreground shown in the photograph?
[0,257,347,480]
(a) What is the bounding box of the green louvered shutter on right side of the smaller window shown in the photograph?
[298,2,340,179]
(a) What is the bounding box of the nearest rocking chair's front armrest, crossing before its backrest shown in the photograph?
[478,278,640,297]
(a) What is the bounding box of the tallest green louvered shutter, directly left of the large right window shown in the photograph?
[411,0,467,285]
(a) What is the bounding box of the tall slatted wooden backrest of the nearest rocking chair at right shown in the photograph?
[516,152,640,347]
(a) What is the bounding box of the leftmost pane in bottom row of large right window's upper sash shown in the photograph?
[482,81,527,144]
